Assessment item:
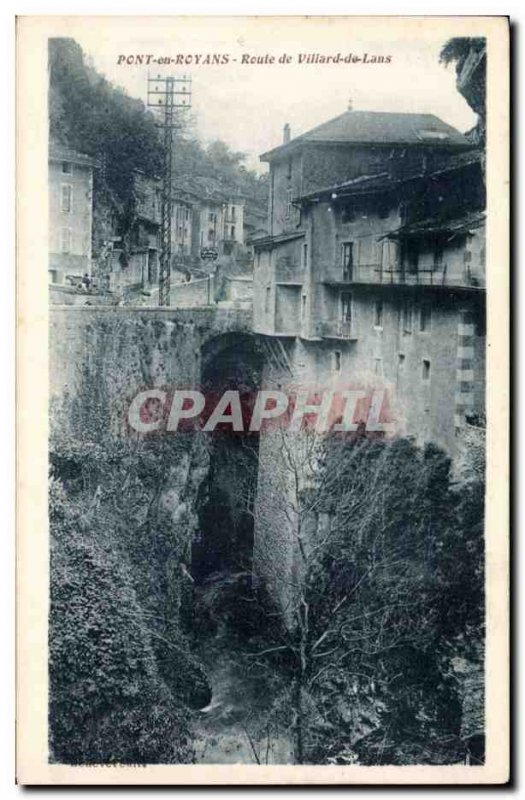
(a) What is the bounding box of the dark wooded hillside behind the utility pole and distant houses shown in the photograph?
[49,38,267,254]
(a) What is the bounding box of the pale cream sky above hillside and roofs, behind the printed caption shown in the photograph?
[71,17,476,171]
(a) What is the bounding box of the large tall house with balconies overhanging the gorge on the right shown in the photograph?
[254,111,485,450]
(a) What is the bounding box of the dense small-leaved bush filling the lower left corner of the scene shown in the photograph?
[49,479,192,764]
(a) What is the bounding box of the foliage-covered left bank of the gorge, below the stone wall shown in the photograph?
[49,340,210,763]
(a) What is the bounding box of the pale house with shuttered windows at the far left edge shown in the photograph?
[48,145,95,284]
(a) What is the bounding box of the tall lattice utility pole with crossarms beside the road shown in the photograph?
[148,75,191,306]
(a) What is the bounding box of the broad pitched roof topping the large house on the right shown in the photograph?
[260,111,472,161]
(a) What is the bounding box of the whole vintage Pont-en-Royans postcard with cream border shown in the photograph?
[17,16,509,784]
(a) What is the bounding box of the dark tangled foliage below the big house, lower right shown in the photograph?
[235,440,484,765]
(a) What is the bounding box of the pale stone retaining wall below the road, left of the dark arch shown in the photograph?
[49,306,251,418]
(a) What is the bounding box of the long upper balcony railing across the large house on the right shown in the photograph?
[324,264,485,289]
